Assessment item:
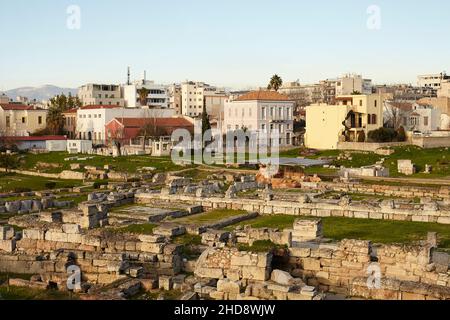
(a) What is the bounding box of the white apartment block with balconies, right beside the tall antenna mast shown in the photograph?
[123,80,169,108]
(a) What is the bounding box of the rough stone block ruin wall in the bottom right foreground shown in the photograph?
[288,240,450,299]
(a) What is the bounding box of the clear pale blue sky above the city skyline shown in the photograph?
[0,0,450,90]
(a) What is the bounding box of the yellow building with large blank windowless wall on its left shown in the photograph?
[305,94,383,150]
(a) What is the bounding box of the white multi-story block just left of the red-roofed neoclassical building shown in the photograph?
[181,81,225,117]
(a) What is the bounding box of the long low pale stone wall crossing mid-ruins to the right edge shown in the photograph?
[136,193,450,224]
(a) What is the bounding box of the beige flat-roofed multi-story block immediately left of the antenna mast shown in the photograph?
[78,83,125,107]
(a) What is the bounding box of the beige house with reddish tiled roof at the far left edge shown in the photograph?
[0,104,47,136]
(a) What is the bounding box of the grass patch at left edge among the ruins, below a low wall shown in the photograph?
[0,173,82,193]
